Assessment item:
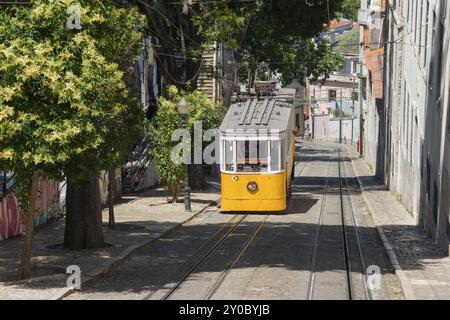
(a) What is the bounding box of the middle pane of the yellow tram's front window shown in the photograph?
[237,140,269,172]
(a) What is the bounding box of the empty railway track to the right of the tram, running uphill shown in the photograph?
[306,151,373,300]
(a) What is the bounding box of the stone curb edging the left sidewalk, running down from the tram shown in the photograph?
[54,198,220,300]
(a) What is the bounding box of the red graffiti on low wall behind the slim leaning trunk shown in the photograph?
[0,180,59,240]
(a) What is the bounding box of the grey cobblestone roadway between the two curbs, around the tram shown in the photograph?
[67,142,404,300]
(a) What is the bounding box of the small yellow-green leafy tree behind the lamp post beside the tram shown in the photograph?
[149,86,225,202]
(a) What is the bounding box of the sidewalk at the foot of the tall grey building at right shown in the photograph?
[350,151,450,300]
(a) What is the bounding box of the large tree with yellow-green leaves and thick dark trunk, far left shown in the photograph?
[0,0,143,277]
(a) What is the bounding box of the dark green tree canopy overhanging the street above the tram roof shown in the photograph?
[116,0,344,90]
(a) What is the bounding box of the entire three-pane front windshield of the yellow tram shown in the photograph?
[222,140,284,173]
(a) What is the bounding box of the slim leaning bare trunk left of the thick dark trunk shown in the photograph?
[18,170,39,280]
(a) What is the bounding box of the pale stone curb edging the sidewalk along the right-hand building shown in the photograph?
[351,152,416,300]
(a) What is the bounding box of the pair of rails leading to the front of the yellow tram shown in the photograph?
[161,214,270,300]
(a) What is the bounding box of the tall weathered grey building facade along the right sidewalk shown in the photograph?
[360,0,450,252]
